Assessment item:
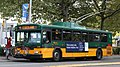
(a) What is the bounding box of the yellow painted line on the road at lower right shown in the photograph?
[48,62,120,67]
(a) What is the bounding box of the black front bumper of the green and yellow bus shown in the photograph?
[14,54,42,59]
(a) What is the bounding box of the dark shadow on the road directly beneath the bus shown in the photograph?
[9,58,104,63]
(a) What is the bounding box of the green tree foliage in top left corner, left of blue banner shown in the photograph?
[0,0,29,18]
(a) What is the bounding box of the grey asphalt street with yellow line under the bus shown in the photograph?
[0,55,120,67]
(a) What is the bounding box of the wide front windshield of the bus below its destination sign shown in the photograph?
[17,32,41,43]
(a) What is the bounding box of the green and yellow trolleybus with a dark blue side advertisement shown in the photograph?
[14,22,112,61]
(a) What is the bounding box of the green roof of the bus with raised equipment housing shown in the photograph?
[16,22,111,33]
